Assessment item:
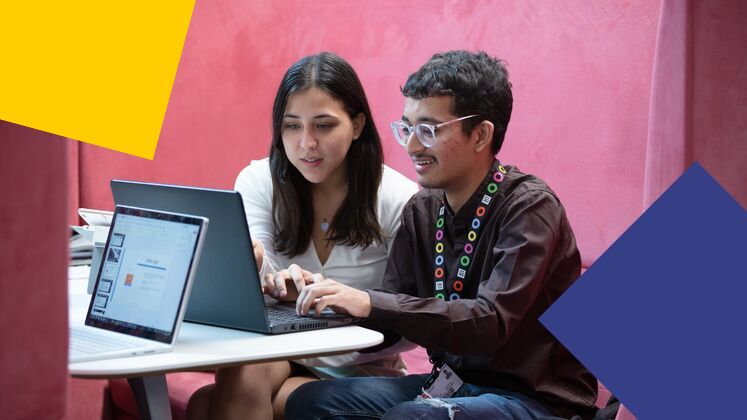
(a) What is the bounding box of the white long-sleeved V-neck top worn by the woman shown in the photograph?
[234,158,418,377]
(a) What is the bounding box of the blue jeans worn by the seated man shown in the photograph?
[285,374,552,420]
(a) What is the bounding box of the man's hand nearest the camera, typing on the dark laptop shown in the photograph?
[296,279,371,318]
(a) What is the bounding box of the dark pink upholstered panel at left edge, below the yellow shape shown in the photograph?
[0,121,69,419]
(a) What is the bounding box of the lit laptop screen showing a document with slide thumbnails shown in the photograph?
[86,206,204,343]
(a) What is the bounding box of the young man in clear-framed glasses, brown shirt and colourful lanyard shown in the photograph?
[286,51,597,419]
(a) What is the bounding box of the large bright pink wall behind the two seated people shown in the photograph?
[80,0,659,263]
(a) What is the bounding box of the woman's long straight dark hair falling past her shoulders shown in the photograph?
[270,52,384,258]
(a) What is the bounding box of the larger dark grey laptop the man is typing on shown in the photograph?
[111,180,356,334]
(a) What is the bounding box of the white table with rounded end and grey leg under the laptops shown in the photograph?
[68,269,383,419]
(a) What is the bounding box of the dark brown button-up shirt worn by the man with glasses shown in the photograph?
[368,163,597,417]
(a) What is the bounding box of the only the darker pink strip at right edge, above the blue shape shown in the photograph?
[690,0,747,208]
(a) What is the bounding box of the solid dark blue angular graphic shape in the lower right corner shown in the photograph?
[541,163,747,420]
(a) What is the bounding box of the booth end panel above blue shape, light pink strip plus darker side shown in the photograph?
[644,0,747,207]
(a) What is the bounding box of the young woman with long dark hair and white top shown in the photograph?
[188,53,417,419]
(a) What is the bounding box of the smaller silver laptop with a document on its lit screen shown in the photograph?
[69,206,208,363]
